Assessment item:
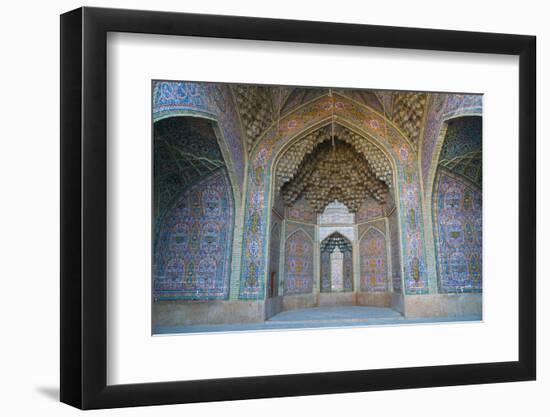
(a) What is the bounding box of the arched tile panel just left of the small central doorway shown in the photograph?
[284,230,313,295]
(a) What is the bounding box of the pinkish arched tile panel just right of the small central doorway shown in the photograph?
[359,228,388,292]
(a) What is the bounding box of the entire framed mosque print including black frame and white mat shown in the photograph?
[61,8,536,409]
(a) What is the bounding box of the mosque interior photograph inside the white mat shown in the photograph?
[151,81,482,334]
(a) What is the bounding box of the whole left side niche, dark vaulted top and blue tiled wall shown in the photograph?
[153,116,236,301]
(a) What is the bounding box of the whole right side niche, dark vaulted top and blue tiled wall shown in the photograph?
[431,116,483,293]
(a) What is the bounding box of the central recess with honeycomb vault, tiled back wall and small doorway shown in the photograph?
[268,123,401,310]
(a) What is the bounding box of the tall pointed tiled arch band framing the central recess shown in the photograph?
[239,94,428,299]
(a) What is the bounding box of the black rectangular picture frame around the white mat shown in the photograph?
[60,7,536,409]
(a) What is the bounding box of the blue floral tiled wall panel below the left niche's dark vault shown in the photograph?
[153,169,234,300]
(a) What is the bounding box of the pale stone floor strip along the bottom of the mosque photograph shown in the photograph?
[153,306,481,334]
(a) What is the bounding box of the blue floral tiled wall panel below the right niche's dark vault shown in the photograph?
[433,169,482,293]
